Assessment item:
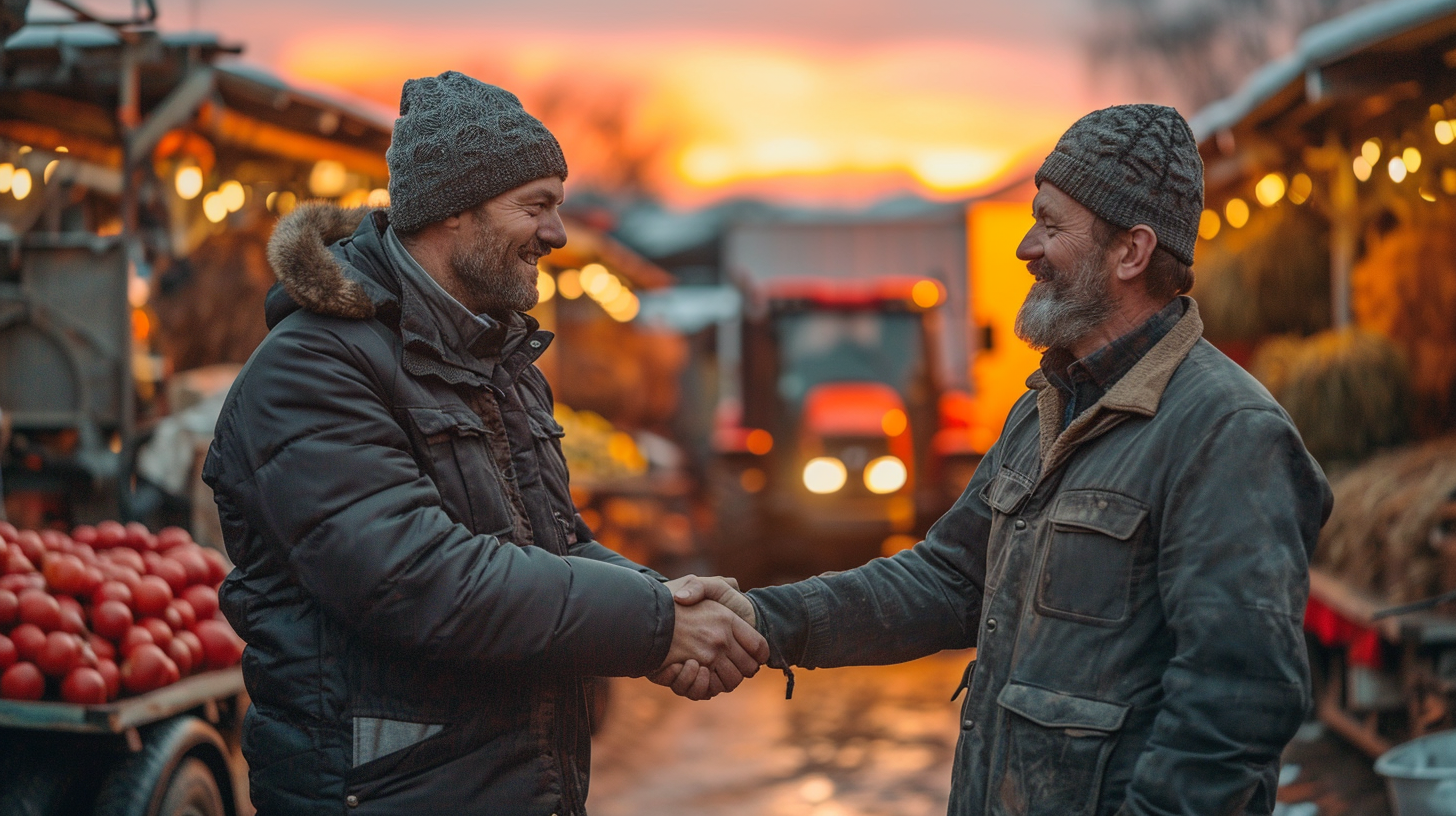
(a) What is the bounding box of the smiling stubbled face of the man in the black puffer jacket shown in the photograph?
[450,176,566,313]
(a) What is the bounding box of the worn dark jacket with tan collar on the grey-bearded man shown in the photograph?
[750,299,1331,816]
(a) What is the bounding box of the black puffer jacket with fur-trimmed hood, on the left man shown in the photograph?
[204,205,673,816]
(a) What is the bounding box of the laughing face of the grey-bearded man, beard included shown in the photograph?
[1015,184,1117,350]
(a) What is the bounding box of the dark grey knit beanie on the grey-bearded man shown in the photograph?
[1037,105,1203,267]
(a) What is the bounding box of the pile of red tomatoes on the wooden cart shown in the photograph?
[0,522,243,705]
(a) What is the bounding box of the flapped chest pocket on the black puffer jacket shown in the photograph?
[408,408,515,536]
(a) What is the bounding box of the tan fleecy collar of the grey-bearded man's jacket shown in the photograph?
[1026,296,1203,474]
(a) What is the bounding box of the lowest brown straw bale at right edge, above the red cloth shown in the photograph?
[1313,437,1456,603]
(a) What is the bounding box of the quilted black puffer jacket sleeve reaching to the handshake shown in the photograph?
[218,326,674,676]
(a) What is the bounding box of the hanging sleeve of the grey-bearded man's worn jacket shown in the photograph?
[1123,408,1331,816]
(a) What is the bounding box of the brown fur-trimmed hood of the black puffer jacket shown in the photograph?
[268,201,376,322]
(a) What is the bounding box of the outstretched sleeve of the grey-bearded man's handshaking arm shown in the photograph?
[748,449,994,669]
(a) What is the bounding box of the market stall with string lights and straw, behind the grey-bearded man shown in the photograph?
[1191,0,1456,753]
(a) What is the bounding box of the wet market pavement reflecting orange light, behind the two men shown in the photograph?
[588,651,1390,816]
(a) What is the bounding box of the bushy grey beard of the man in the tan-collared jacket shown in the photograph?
[1015,249,1117,351]
